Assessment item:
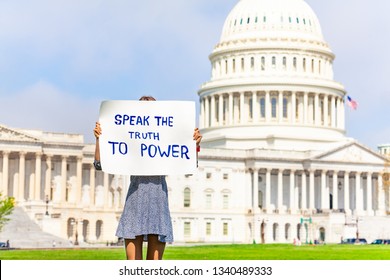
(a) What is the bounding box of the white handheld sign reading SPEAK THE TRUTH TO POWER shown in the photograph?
[99,100,196,175]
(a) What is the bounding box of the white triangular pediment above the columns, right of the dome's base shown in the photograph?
[313,142,386,164]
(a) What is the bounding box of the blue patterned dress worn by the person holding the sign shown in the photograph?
[95,162,173,242]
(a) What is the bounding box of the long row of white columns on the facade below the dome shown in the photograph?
[251,169,386,215]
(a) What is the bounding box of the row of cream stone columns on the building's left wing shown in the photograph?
[0,151,109,206]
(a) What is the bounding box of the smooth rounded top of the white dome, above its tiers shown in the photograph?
[220,0,323,43]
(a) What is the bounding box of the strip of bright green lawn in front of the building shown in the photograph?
[0,244,390,260]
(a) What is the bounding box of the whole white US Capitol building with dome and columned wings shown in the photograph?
[0,0,390,244]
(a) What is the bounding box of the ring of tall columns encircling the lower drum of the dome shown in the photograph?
[200,91,345,129]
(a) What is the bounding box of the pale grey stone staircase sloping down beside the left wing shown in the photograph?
[0,207,73,248]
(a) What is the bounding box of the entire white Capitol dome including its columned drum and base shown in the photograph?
[198,0,346,150]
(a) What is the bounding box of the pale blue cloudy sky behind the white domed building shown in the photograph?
[0,0,390,150]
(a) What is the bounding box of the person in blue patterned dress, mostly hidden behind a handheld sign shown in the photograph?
[94,96,202,260]
